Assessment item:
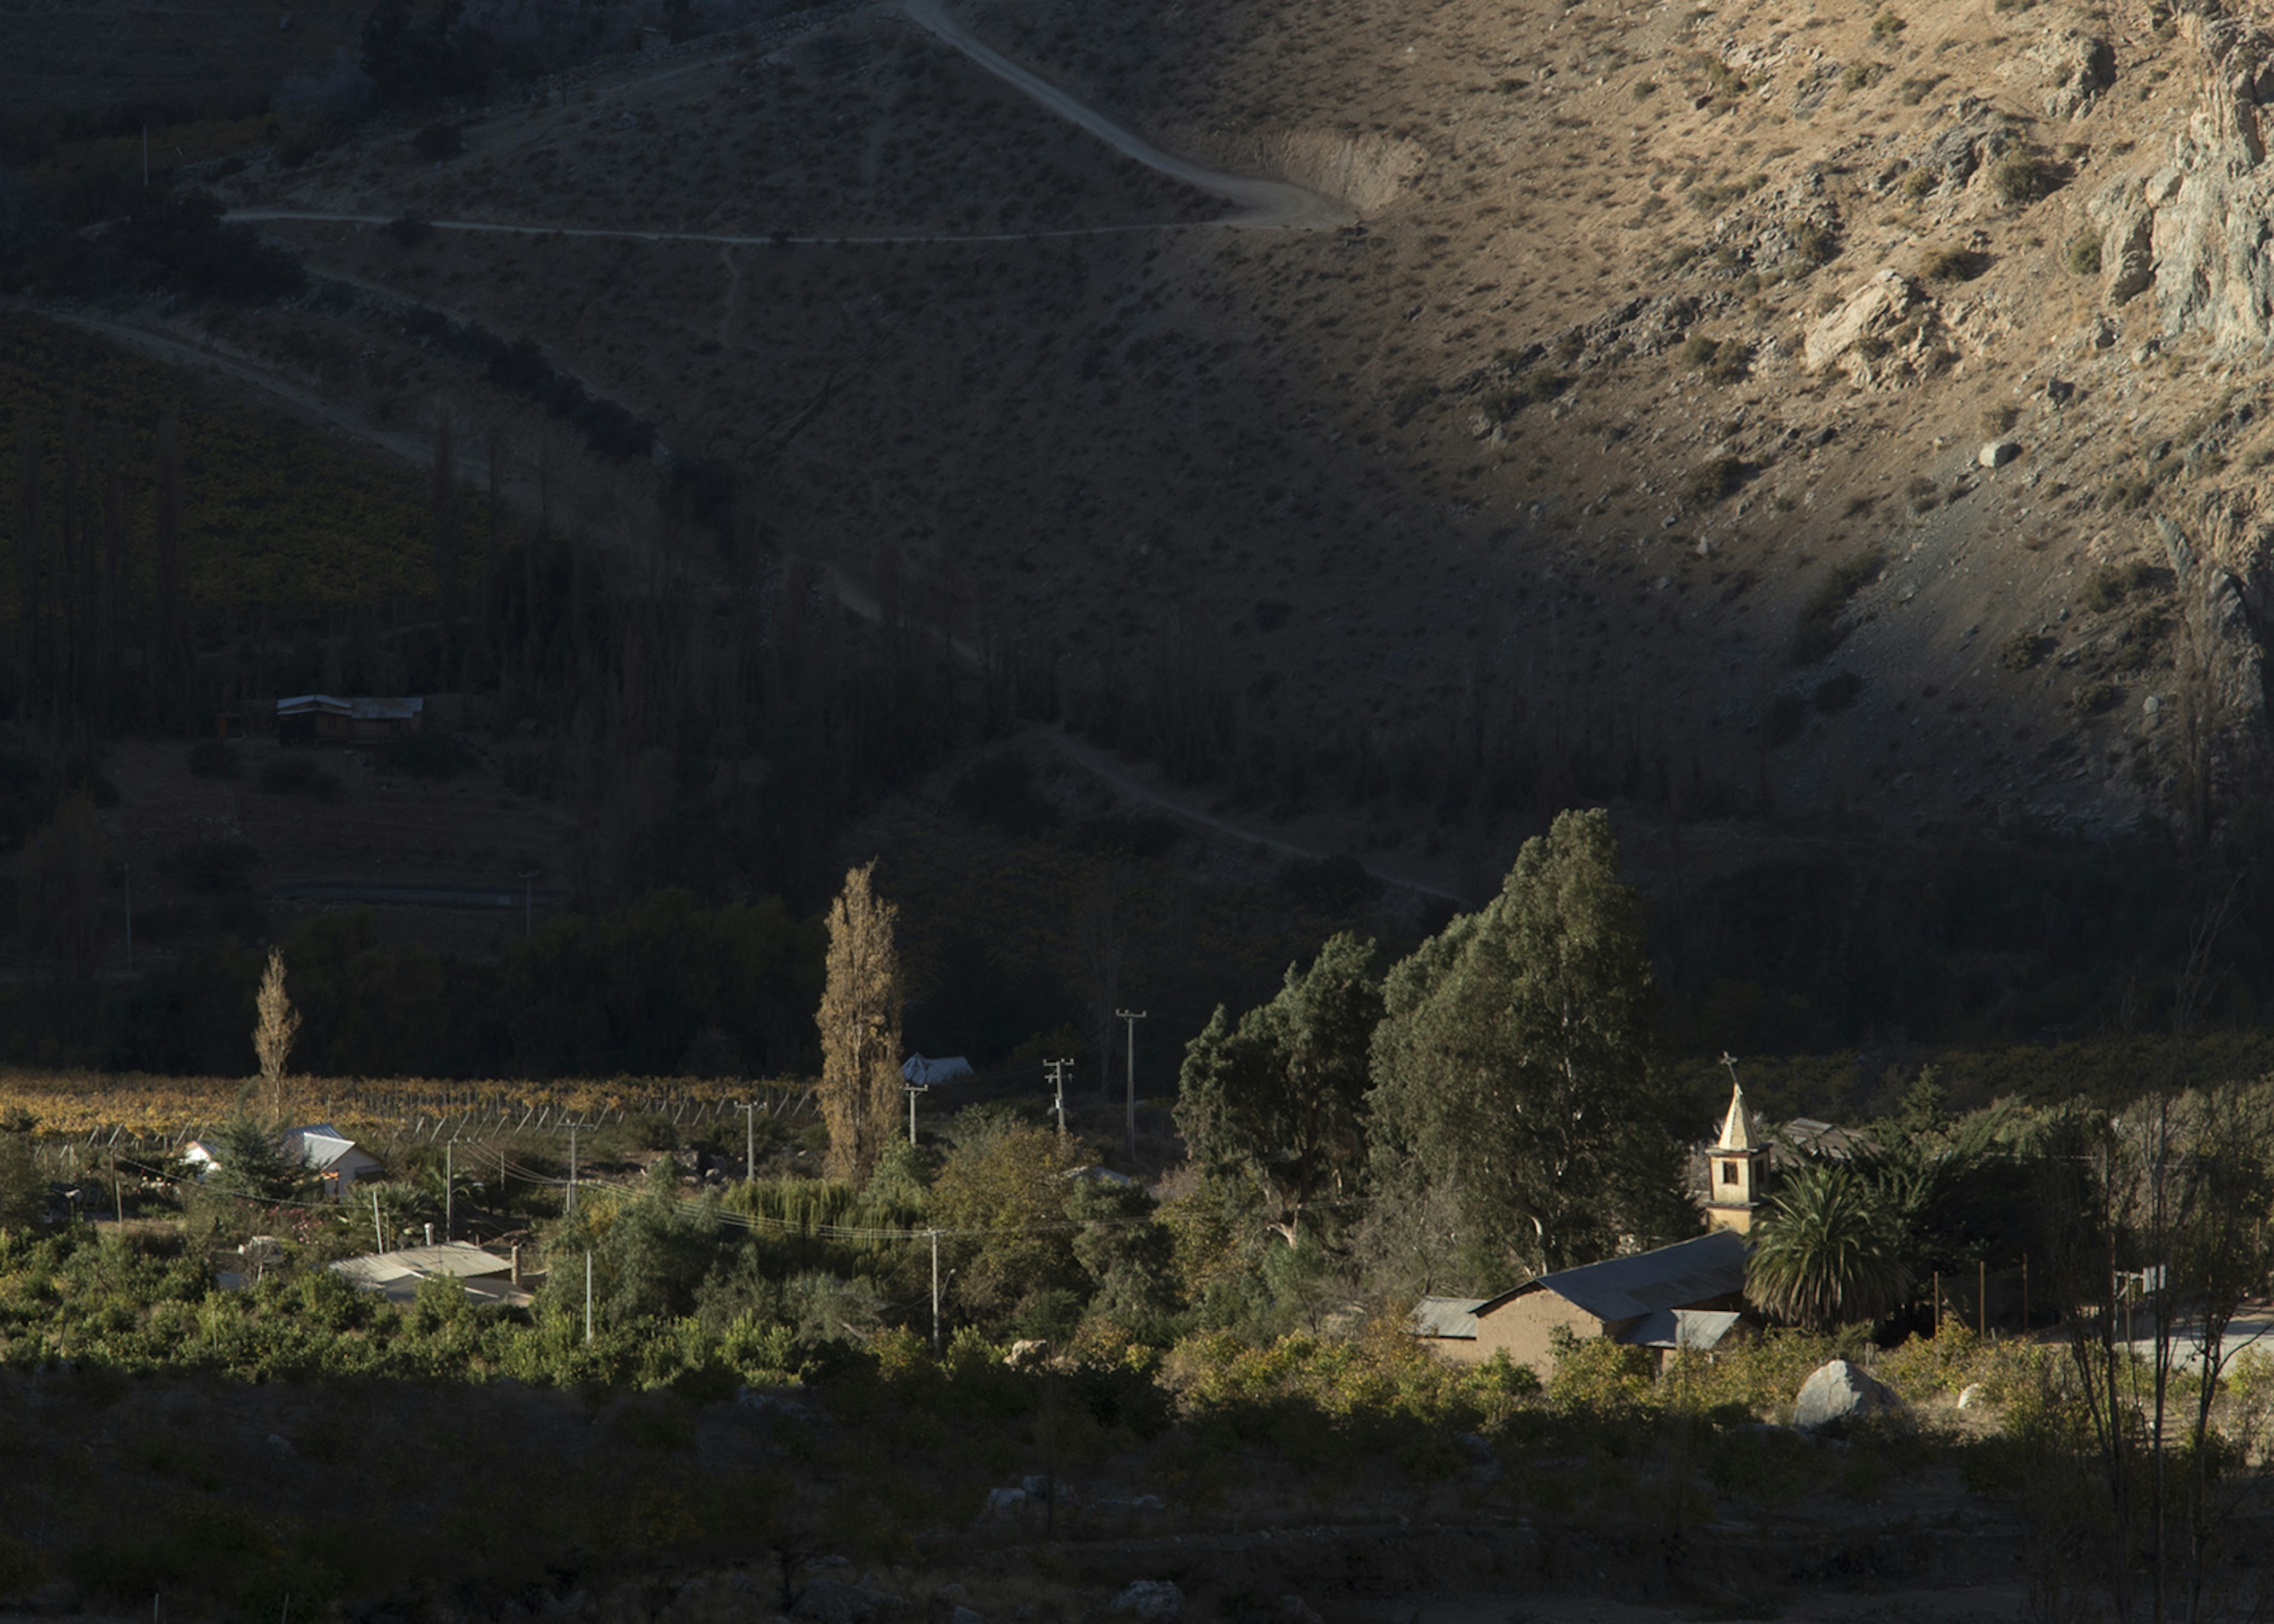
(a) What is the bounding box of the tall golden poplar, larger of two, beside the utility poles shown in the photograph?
[818,862,901,1183]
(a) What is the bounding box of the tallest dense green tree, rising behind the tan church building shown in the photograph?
[1369,812,1694,1285]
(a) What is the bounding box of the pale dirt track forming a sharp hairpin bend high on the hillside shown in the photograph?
[225,0,1356,248]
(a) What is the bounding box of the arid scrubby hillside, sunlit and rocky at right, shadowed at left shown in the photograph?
[31,0,2274,885]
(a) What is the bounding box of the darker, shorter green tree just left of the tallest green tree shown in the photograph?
[1175,932,1383,1246]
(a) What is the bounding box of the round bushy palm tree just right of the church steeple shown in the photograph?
[1744,1162,1910,1330]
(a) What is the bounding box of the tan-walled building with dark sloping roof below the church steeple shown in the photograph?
[1410,1229,1749,1376]
